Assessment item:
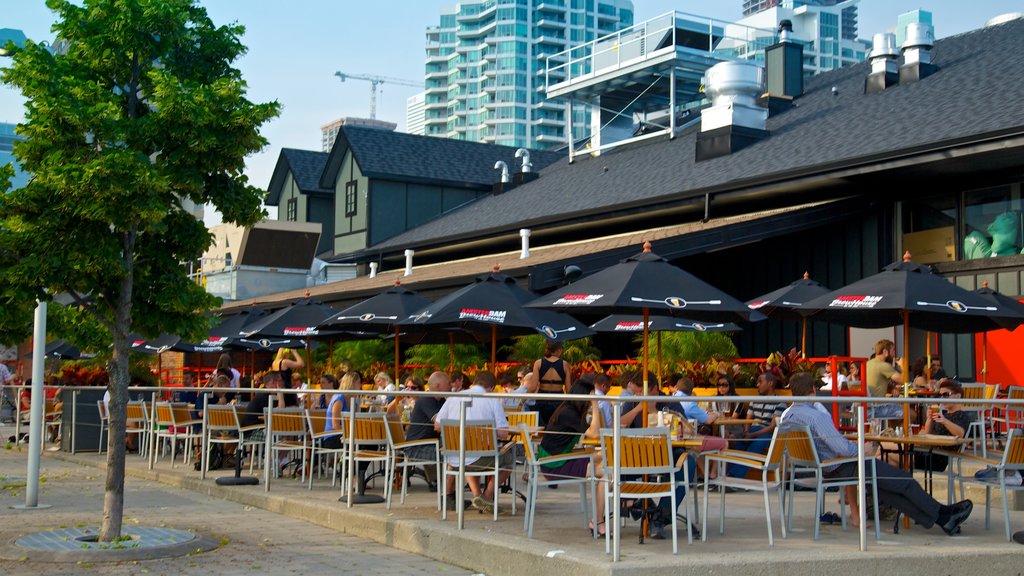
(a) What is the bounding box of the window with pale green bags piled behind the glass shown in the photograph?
[964,183,1024,260]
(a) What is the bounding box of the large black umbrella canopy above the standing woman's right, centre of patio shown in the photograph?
[526,242,765,322]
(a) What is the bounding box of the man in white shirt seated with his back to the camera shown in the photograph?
[434,370,515,512]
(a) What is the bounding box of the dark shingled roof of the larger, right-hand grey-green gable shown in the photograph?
[319,126,565,188]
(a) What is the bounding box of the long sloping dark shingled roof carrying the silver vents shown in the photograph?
[368,19,1024,253]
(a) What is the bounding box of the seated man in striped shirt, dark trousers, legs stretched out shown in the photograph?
[780,378,974,536]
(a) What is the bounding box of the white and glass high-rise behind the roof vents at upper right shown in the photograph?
[736,0,870,76]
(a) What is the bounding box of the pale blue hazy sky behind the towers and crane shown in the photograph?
[0,0,1024,224]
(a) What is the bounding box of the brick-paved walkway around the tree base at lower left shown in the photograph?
[0,420,471,576]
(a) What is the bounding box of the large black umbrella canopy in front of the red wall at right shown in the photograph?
[798,252,1024,333]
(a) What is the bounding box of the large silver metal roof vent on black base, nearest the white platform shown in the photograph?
[696,61,768,162]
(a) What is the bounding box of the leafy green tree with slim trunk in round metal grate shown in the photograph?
[0,0,280,541]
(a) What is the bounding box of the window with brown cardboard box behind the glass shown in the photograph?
[902,194,956,264]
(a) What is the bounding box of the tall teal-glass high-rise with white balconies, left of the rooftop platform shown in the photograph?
[423,0,633,149]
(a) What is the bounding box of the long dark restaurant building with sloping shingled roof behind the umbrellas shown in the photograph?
[227,14,1024,382]
